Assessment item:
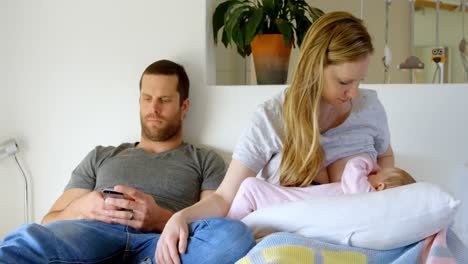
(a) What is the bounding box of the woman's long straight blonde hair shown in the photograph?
[280,12,374,186]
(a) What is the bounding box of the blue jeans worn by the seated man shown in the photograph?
[0,218,255,264]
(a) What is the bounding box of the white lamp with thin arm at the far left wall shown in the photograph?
[0,139,32,223]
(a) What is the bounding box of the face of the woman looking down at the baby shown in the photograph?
[322,55,371,106]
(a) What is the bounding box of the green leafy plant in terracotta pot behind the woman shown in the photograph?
[213,0,323,84]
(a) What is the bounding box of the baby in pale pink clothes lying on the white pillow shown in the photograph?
[227,156,416,219]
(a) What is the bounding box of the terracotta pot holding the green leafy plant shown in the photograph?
[250,34,292,84]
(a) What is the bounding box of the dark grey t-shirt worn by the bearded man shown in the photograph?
[65,143,226,211]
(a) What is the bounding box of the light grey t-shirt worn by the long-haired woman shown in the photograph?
[232,89,390,184]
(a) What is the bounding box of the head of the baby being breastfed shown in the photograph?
[368,167,416,191]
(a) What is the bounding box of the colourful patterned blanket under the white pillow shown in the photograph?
[236,230,468,264]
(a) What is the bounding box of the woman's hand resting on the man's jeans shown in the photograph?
[155,212,189,264]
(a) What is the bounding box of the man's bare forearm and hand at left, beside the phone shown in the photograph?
[41,188,112,224]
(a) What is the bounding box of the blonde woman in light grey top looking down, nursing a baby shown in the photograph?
[156,12,394,263]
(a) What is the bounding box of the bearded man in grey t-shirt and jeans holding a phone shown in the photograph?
[0,60,254,263]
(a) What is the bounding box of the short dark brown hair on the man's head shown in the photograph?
[140,60,190,105]
